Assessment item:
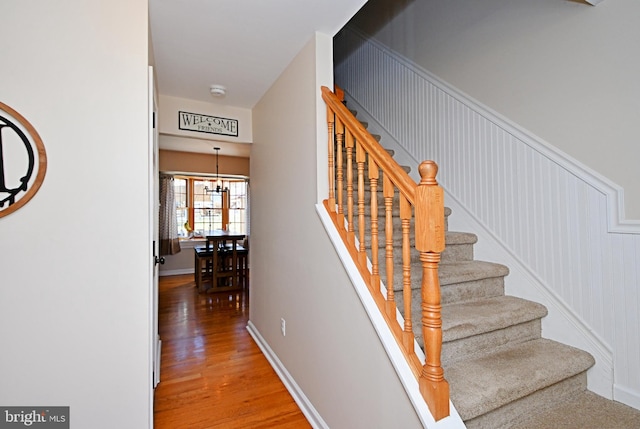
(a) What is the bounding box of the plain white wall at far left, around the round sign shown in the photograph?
[0,0,151,429]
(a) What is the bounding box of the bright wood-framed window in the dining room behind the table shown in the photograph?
[173,176,247,237]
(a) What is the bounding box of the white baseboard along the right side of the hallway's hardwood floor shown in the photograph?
[242,321,329,429]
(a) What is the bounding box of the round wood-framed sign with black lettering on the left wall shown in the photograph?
[0,102,47,217]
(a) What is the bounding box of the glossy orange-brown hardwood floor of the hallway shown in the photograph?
[154,275,311,429]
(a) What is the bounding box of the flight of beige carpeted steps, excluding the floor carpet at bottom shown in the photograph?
[342,106,604,429]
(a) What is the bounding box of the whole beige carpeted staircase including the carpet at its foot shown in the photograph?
[343,112,640,429]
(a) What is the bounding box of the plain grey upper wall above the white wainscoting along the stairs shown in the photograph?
[348,0,640,219]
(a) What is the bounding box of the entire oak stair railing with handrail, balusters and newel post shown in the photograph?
[322,86,449,420]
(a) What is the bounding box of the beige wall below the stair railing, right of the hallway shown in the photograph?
[251,35,421,429]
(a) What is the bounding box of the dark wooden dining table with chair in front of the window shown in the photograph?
[195,229,245,292]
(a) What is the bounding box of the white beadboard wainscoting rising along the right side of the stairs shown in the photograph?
[335,29,640,409]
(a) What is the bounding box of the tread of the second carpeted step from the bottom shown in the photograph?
[442,295,547,342]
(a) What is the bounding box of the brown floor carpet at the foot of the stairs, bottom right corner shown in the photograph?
[511,391,640,429]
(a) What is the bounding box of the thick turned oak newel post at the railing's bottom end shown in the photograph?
[415,161,449,420]
